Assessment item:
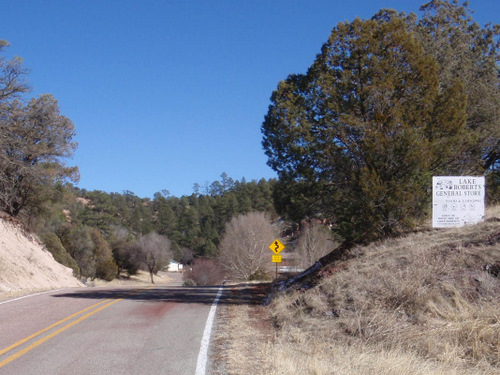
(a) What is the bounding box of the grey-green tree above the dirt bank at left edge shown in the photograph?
[0,40,78,216]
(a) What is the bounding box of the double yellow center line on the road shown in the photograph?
[0,287,152,368]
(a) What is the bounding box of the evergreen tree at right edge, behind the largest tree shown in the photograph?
[414,0,500,174]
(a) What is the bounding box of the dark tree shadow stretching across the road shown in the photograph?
[53,283,271,305]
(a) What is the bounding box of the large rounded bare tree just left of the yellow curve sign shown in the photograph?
[219,212,278,280]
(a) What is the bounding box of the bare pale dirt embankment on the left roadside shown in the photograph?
[0,218,83,299]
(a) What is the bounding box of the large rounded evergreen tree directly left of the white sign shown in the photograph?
[262,16,474,241]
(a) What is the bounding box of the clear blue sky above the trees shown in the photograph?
[0,0,500,197]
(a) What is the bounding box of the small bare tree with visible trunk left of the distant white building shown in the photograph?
[137,232,172,284]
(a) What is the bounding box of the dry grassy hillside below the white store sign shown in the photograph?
[262,207,500,375]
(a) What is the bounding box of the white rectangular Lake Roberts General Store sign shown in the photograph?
[432,176,485,228]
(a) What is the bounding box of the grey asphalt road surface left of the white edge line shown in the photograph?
[0,274,223,375]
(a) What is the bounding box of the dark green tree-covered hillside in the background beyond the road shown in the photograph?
[32,174,276,280]
